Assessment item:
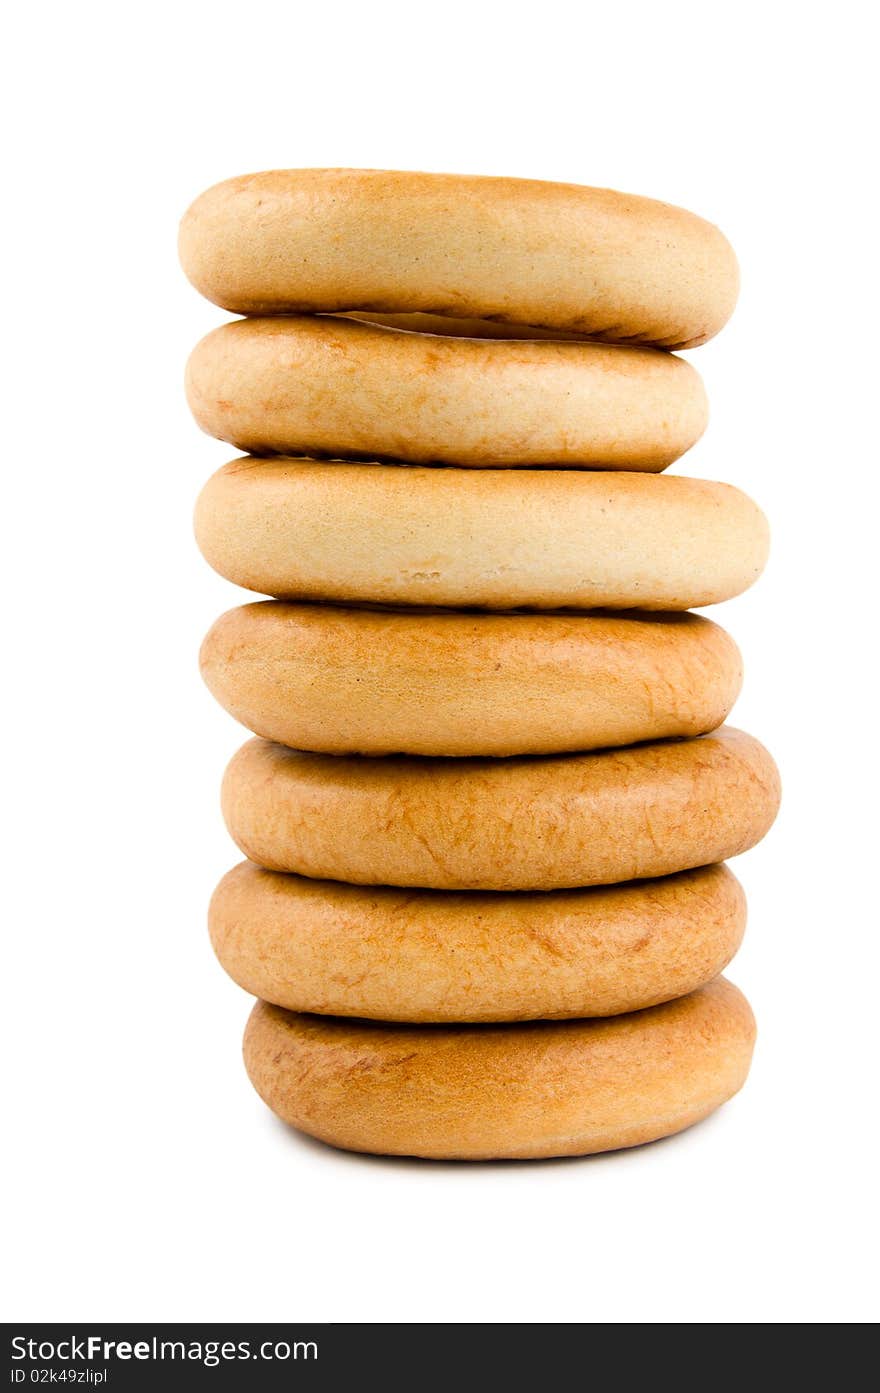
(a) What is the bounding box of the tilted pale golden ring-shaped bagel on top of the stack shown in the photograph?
[180,169,739,348]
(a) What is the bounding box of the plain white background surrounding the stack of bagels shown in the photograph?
[3,0,880,1323]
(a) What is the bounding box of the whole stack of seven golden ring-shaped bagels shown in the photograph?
[181,170,780,1159]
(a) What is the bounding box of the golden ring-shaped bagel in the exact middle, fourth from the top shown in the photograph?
[201,600,742,755]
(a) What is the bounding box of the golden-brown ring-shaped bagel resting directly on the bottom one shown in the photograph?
[209,861,745,1022]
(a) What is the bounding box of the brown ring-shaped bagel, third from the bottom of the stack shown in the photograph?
[223,727,780,890]
